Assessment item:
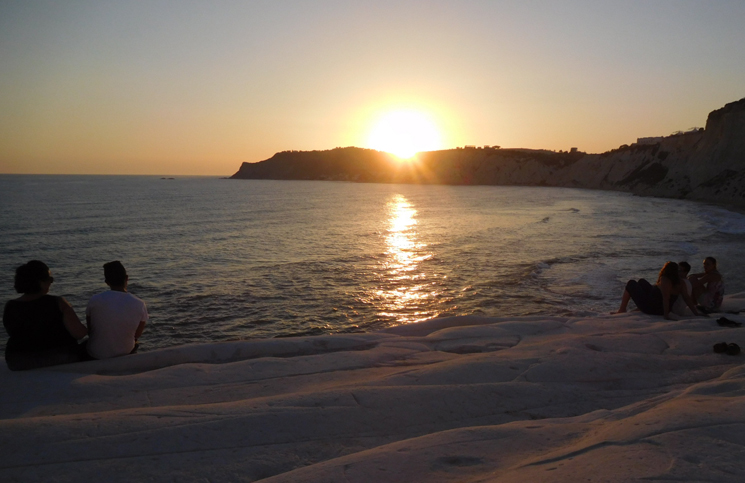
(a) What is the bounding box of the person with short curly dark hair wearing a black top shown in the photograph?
[3,260,88,371]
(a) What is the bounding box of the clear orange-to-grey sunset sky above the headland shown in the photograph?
[0,0,745,176]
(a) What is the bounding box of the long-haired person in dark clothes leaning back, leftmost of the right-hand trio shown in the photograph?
[617,262,698,319]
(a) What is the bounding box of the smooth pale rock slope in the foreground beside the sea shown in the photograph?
[0,294,745,482]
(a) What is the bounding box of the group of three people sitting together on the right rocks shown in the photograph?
[617,257,724,319]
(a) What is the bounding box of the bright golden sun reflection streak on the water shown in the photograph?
[374,194,437,324]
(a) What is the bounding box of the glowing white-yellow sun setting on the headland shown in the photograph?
[367,110,441,159]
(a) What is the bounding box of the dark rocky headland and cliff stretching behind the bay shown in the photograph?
[232,99,745,206]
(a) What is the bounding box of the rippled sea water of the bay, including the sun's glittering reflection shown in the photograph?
[0,175,745,350]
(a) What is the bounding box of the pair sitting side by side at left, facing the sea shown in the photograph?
[3,260,148,371]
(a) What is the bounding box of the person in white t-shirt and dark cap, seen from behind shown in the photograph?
[85,261,148,359]
